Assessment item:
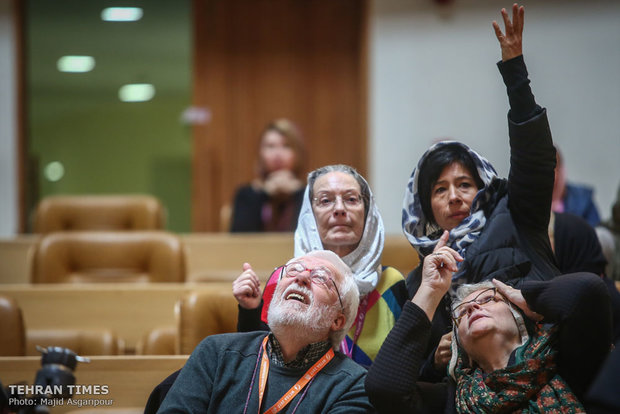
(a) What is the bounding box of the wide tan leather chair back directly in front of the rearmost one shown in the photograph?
[31,231,185,283]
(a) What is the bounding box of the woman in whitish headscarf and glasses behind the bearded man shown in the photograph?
[233,165,407,366]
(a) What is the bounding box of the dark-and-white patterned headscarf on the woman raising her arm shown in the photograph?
[402,141,498,275]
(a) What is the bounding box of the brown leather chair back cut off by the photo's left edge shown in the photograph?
[0,296,26,356]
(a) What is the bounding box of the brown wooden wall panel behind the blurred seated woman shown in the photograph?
[192,0,367,231]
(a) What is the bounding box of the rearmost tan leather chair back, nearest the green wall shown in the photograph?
[33,195,165,233]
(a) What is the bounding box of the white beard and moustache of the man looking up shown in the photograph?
[267,284,336,344]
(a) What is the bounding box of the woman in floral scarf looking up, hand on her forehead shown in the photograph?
[366,232,611,413]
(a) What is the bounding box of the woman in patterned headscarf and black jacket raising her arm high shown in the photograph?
[402,4,559,380]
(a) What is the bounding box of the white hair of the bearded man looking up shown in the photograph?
[291,250,359,351]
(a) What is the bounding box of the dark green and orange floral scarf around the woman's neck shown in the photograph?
[455,325,585,413]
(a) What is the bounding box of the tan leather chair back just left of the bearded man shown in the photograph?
[177,285,238,355]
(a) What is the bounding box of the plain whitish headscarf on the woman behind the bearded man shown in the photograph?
[295,164,385,296]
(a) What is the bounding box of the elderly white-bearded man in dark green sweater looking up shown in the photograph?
[158,250,374,413]
